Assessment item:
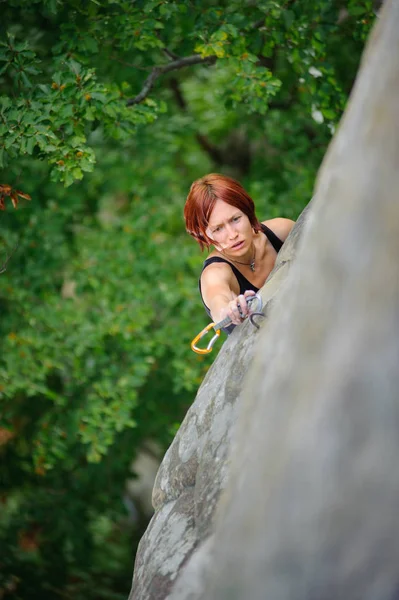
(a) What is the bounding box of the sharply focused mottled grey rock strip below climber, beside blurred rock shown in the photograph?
[129,203,306,600]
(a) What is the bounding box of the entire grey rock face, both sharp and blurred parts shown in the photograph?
[130,0,399,600]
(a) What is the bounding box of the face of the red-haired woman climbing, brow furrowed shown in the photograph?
[206,200,253,256]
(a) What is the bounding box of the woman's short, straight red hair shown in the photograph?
[184,173,261,250]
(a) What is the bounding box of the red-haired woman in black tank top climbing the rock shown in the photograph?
[184,173,294,333]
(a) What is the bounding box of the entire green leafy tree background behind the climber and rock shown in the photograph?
[0,0,378,600]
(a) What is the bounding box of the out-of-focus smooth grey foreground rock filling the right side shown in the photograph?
[203,0,399,600]
